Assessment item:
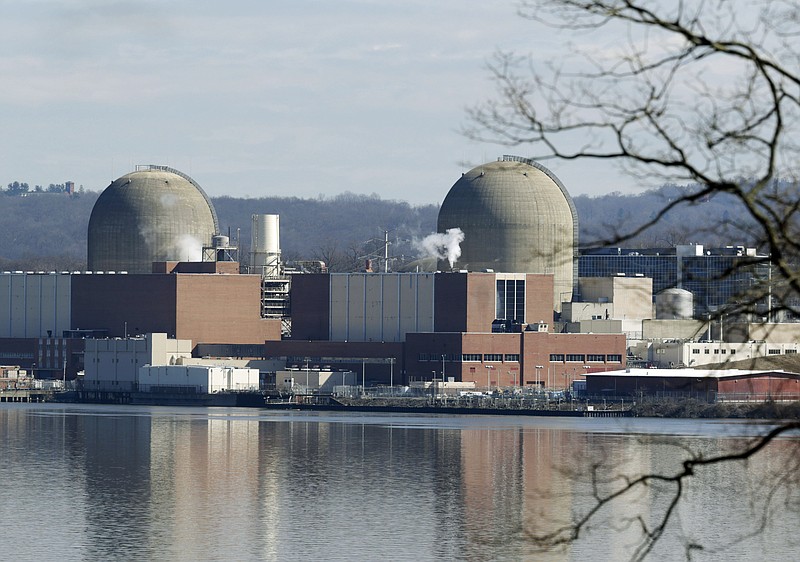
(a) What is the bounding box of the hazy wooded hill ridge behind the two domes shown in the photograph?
[0,186,757,271]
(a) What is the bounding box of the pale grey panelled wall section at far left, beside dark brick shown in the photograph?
[0,273,71,338]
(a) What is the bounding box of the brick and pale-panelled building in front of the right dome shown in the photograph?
[265,272,626,388]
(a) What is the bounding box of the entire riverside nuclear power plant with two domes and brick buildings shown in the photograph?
[0,156,797,396]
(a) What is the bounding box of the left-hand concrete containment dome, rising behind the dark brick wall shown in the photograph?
[87,166,219,273]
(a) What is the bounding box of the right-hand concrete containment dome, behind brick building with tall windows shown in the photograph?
[438,156,578,310]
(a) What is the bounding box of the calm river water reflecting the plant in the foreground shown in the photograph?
[0,404,800,561]
